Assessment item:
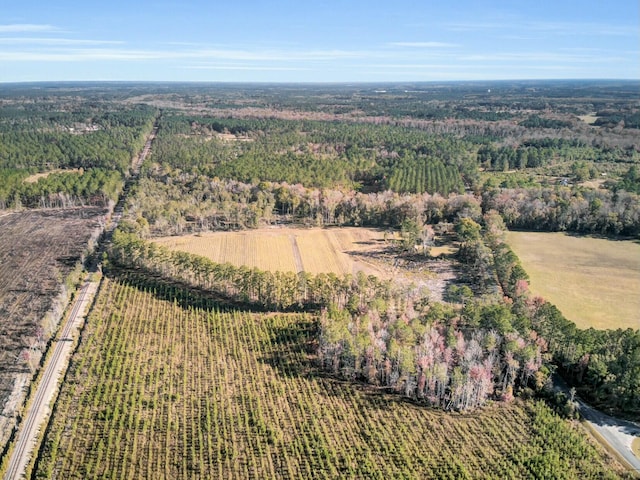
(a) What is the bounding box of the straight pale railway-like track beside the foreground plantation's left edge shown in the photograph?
[4,277,98,480]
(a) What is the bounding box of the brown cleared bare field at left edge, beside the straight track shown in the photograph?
[0,208,104,450]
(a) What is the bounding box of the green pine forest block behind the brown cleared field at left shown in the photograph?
[0,104,156,208]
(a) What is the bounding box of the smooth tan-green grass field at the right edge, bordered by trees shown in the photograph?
[507,232,640,329]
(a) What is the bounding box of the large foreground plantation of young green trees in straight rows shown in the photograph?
[35,277,621,480]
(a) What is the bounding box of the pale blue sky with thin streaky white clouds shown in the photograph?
[0,0,640,82]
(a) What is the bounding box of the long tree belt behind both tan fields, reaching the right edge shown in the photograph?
[121,166,640,240]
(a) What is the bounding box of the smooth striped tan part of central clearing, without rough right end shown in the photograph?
[154,228,386,277]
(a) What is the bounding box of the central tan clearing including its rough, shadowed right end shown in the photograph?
[153,227,459,301]
